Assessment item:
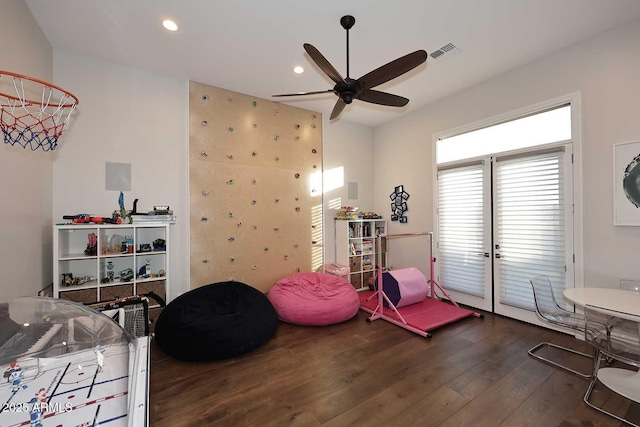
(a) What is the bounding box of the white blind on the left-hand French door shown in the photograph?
[438,163,485,298]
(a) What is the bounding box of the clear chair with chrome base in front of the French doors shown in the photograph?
[529,275,593,380]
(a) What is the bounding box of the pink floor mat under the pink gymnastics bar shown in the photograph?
[359,291,479,338]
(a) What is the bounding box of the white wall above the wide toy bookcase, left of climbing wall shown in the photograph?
[53,50,189,299]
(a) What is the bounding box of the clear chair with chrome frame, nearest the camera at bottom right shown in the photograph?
[584,305,640,427]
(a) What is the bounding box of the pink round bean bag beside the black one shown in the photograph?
[268,273,360,326]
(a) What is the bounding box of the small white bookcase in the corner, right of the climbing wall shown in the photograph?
[335,219,387,290]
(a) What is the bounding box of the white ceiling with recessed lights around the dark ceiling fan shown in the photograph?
[26,0,640,127]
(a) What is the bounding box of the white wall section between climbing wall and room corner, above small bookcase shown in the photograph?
[322,117,374,263]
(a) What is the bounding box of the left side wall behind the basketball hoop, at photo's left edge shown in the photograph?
[0,0,53,302]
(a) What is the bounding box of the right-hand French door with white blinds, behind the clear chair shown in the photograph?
[493,147,573,318]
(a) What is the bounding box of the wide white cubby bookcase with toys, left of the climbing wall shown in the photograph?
[53,222,173,307]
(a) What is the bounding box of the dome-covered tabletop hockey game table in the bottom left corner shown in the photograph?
[0,297,149,427]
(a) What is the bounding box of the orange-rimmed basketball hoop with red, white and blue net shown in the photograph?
[0,71,78,151]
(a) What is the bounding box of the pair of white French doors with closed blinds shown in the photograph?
[437,144,574,323]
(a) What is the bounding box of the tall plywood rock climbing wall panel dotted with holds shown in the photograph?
[189,82,323,292]
